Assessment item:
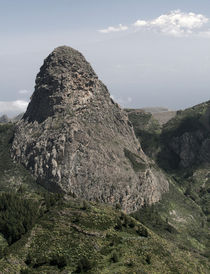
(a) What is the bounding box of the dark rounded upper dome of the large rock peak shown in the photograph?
[23,46,98,123]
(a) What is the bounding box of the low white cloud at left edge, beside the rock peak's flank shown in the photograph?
[0,100,28,113]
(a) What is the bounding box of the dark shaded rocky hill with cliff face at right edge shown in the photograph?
[160,101,210,169]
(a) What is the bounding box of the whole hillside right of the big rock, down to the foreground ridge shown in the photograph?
[128,102,210,264]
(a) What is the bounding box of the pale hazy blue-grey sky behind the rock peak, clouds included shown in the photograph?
[0,0,210,117]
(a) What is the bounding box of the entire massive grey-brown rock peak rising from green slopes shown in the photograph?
[11,46,168,212]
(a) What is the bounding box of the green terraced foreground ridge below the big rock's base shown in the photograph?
[0,193,209,274]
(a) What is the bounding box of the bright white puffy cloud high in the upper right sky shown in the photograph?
[133,10,209,36]
